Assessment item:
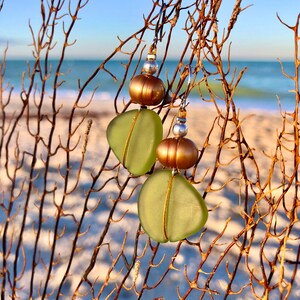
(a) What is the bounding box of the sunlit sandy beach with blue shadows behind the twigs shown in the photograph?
[0,93,300,299]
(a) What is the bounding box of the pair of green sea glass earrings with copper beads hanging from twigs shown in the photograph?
[107,5,208,243]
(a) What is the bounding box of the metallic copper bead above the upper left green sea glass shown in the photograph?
[129,74,165,106]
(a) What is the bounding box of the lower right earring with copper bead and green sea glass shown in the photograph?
[138,67,208,243]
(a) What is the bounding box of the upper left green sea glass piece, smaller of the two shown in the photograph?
[106,108,163,176]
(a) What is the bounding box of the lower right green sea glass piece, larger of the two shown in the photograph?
[138,170,208,243]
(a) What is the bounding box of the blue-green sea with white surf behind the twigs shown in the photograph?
[1,60,295,111]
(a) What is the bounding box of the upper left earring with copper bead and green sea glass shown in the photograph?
[106,4,165,176]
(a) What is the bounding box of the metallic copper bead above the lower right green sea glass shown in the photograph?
[156,137,198,169]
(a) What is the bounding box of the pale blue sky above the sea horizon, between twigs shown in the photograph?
[0,0,300,60]
